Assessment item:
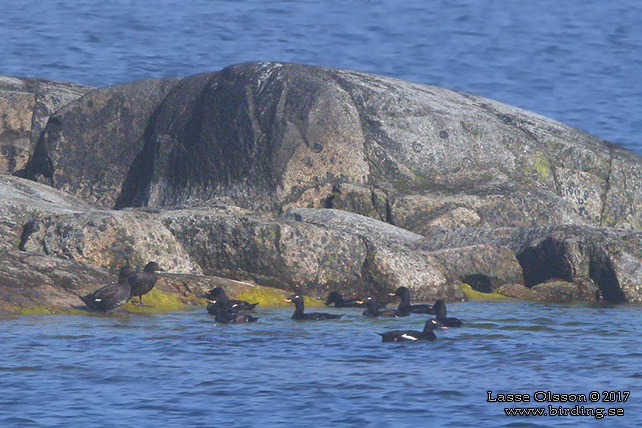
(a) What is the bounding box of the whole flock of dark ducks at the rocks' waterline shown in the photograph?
[81,262,462,342]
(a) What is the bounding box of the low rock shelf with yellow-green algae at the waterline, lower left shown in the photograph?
[0,250,286,315]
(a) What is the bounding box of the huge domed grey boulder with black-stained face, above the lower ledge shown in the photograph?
[21,63,642,233]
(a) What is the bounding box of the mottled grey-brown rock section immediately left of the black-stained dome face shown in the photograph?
[24,79,178,208]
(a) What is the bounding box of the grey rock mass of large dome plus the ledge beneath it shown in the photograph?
[0,63,642,310]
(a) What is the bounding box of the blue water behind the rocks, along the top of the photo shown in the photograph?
[0,0,642,154]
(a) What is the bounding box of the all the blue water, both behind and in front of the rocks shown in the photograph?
[0,0,642,427]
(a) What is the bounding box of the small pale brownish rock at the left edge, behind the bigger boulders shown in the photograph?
[0,76,92,174]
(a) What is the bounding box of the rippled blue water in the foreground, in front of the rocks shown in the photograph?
[0,301,642,427]
